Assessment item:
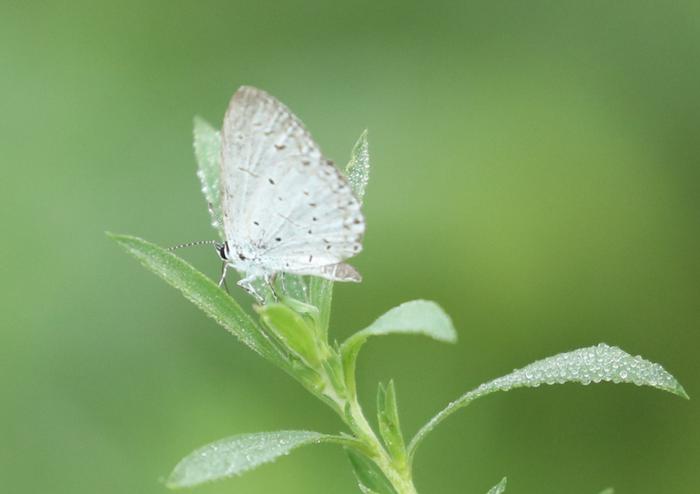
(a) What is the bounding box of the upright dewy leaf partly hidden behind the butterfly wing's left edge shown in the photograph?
[194,117,225,239]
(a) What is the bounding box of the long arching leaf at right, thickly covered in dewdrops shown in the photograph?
[408,343,688,461]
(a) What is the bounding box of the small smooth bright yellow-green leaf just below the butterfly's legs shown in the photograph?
[256,303,321,369]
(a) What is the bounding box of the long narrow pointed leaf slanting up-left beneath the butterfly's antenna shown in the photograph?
[107,233,287,367]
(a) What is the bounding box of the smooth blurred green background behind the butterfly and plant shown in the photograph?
[0,1,700,494]
